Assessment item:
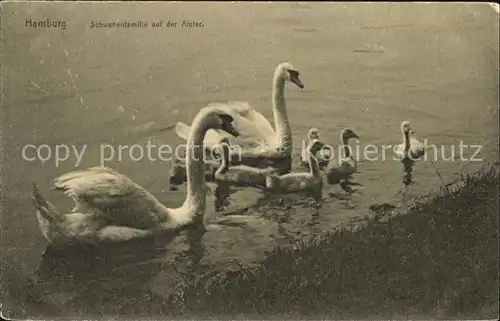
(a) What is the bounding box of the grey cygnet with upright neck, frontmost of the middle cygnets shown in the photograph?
[266,140,323,200]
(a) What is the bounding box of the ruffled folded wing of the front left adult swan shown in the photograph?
[53,167,164,228]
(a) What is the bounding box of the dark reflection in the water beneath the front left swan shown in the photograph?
[37,228,206,294]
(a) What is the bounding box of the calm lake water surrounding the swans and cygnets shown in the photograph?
[1,3,499,318]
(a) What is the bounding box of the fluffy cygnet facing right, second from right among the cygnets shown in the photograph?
[326,128,359,192]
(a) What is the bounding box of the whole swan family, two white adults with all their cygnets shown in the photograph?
[33,63,424,246]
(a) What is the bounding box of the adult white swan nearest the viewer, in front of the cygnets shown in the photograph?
[33,106,239,246]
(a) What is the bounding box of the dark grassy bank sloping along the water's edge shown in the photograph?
[4,167,499,319]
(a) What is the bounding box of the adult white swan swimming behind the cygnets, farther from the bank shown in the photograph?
[175,62,304,172]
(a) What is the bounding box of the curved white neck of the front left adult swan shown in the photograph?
[182,113,209,219]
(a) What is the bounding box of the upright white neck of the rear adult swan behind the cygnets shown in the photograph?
[273,69,292,154]
